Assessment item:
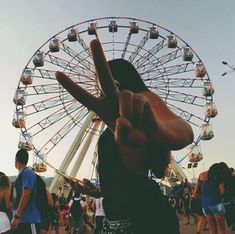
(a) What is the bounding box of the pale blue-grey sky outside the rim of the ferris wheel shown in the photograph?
[0,0,235,181]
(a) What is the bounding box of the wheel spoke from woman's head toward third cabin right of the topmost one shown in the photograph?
[133,39,165,70]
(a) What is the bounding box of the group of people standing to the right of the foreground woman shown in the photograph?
[169,162,235,234]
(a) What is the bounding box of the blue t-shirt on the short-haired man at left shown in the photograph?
[13,167,40,223]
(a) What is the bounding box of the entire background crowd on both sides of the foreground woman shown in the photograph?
[0,154,235,234]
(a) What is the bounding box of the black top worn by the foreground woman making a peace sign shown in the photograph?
[98,130,179,234]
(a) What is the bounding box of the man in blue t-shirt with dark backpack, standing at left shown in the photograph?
[11,149,40,234]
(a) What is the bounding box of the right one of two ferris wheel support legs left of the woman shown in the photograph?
[70,122,105,177]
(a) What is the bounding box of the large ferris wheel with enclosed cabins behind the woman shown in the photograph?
[12,17,217,190]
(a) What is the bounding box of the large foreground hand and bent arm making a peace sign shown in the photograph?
[56,40,193,150]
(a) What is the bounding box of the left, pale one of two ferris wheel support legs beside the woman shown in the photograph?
[49,112,96,193]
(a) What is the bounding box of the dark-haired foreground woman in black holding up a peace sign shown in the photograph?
[56,40,193,234]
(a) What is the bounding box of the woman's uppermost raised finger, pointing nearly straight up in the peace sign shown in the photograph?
[90,39,117,97]
